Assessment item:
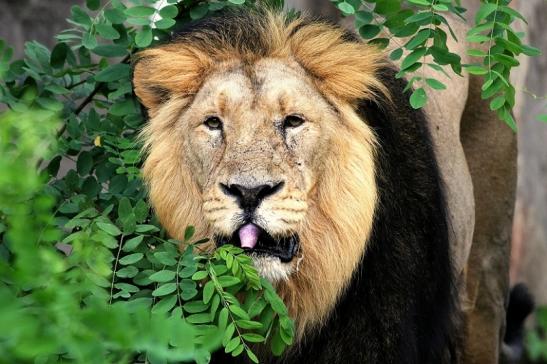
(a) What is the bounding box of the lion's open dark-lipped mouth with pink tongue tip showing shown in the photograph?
[215,223,300,263]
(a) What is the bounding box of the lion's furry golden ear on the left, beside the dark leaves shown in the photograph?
[133,43,211,115]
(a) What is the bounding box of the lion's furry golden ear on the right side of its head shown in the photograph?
[290,23,387,102]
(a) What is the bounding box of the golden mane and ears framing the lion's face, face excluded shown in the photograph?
[134,11,387,337]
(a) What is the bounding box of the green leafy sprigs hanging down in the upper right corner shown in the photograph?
[334,0,540,130]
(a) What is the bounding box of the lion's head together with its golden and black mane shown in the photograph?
[133,9,520,364]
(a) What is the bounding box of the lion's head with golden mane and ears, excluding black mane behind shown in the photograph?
[134,11,384,334]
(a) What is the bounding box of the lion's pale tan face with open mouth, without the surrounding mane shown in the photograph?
[182,59,340,280]
